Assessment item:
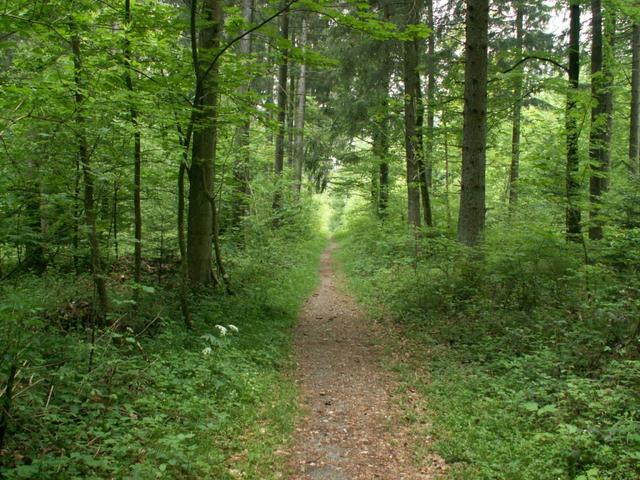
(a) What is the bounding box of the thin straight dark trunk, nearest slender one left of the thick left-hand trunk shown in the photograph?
[124,0,142,300]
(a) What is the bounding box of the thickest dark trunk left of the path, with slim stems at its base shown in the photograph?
[187,0,222,287]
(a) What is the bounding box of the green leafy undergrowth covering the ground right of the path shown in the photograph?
[338,214,640,480]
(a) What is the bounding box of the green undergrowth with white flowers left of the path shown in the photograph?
[0,235,325,479]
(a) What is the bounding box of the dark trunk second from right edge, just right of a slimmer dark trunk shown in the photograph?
[589,0,613,240]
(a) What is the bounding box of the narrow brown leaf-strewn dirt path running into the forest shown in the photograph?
[290,242,435,480]
